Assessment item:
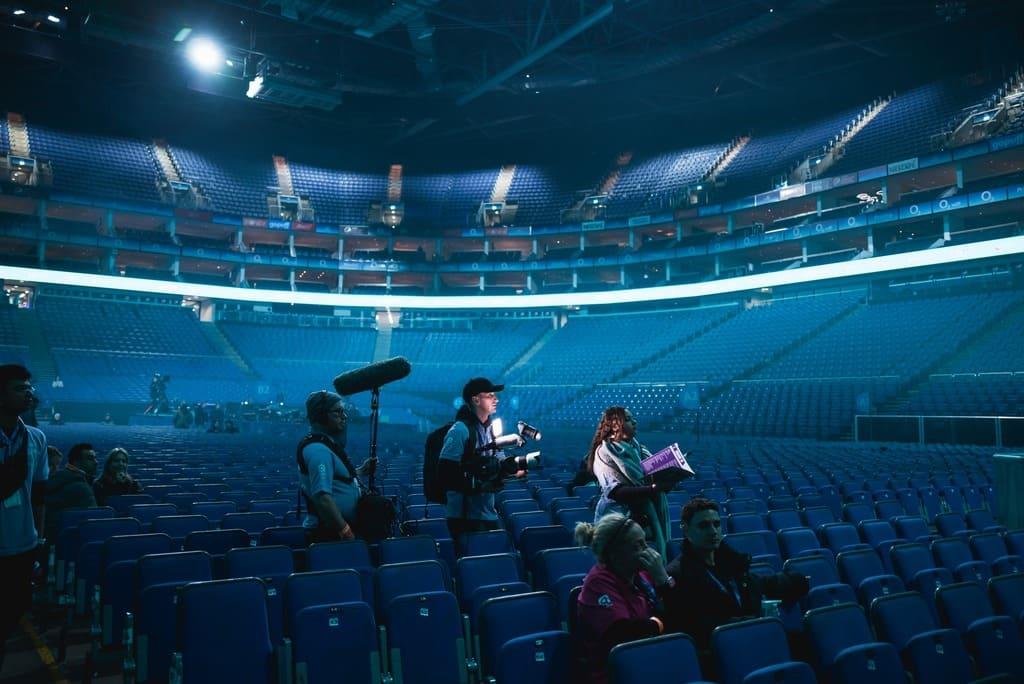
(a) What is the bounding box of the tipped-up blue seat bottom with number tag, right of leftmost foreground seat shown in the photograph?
[292,602,380,684]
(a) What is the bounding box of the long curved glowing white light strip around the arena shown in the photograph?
[6,236,1024,310]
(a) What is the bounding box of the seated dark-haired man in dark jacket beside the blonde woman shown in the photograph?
[666,499,809,660]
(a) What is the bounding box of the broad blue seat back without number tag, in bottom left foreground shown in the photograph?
[175,578,273,684]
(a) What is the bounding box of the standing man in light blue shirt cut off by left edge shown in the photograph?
[0,364,49,673]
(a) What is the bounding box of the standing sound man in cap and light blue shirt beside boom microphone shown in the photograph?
[295,390,373,542]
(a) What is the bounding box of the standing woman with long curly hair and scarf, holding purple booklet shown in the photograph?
[587,407,671,558]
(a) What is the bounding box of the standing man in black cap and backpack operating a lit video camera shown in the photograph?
[437,378,505,544]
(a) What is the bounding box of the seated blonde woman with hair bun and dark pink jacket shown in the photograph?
[575,513,674,684]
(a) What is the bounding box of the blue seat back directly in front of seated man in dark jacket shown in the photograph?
[711,617,790,684]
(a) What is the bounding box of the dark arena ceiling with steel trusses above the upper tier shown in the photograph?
[0,0,1024,165]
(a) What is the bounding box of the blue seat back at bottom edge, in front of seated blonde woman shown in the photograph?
[606,634,702,684]
